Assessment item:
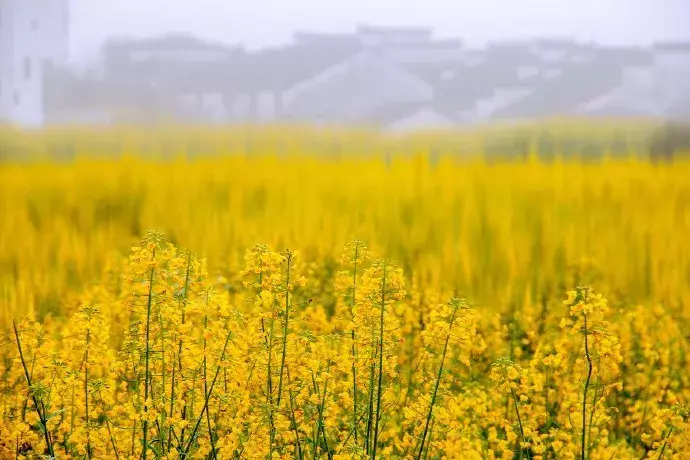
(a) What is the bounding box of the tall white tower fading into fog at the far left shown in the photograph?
[0,0,69,126]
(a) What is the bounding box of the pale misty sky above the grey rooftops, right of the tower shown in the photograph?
[71,0,690,61]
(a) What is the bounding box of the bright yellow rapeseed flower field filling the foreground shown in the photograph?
[0,127,690,460]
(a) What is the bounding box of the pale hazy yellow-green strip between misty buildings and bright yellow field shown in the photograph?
[0,120,690,162]
